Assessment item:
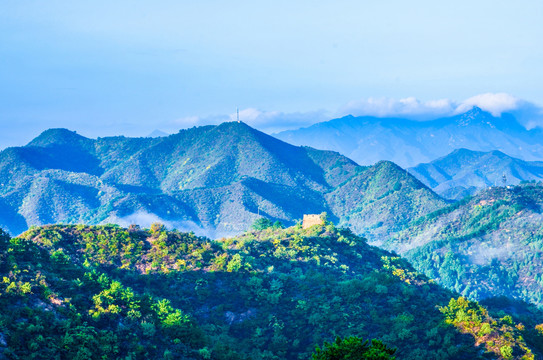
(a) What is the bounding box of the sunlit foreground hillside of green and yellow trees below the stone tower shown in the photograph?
[0,223,543,359]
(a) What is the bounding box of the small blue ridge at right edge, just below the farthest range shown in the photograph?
[408,149,543,200]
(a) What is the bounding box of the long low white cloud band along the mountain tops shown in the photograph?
[152,93,543,139]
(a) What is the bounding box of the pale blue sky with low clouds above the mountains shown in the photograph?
[0,0,543,149]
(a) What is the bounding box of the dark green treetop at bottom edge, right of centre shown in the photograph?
[311,336,396,360]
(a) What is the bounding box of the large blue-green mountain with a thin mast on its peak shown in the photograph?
[0,122,446,239]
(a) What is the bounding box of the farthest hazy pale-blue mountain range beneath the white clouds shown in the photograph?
[275,107,543,167]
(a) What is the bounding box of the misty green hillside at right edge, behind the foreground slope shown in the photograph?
[385,183,543,306]
